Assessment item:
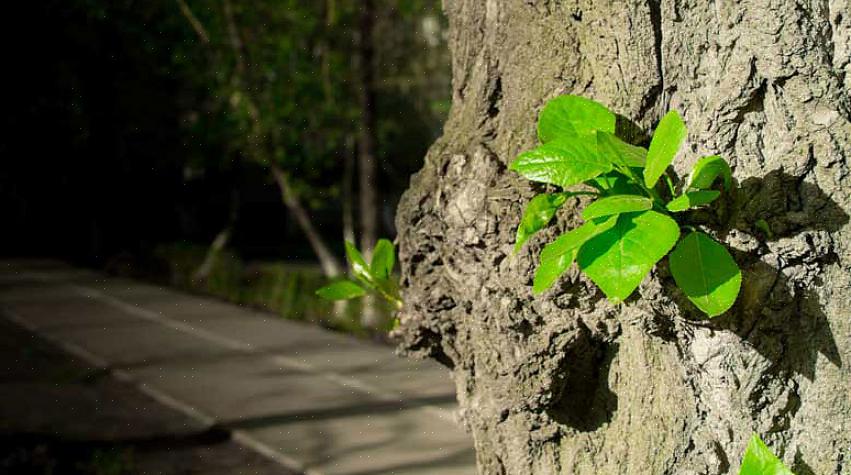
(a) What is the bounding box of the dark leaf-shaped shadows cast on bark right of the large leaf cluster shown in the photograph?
[671,170,849,380]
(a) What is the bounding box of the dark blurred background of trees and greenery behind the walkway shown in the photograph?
[0,0,450,336]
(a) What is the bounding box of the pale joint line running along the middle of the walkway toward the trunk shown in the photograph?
[65,284,458,424]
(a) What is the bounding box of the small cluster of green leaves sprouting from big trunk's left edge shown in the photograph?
[316,239,402,309]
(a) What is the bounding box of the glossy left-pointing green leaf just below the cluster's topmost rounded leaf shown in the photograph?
[511,137,612,188]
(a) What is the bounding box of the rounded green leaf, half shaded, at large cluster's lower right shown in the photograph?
[668,232,742,317]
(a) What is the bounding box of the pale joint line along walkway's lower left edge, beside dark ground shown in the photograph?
[0,307,316,475]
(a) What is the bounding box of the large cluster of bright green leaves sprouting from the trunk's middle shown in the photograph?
[511,95,742,317]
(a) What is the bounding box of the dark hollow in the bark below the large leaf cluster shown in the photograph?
[547,335,618,432]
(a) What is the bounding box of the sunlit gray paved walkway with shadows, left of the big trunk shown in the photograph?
[0,261,475,475]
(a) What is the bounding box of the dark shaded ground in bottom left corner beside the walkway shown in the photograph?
[0,319,300,475]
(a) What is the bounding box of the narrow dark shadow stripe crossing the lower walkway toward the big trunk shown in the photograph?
[223,394,456,429]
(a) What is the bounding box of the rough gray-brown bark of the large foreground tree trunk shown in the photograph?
[397,0,851,475]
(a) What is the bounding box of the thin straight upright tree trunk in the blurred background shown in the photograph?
[357,0,378,327]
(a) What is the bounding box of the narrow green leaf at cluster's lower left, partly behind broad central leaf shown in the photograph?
[532,216,617,294]
